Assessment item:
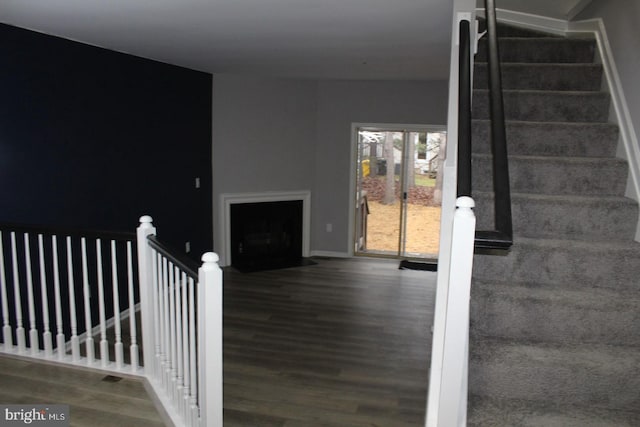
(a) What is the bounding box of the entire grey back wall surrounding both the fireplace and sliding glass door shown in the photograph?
[213,74,447,253]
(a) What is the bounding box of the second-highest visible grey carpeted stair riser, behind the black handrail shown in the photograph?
[475,38,596,63]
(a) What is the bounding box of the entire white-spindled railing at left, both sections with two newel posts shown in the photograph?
[0,216,222,427]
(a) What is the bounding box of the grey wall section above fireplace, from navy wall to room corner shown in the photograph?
[212,74,317,251]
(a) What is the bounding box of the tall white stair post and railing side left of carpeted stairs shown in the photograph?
[425,0,476,427]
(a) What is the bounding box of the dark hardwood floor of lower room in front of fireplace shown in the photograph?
[224,258,435,427]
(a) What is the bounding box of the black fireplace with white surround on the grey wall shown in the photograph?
[220,191,311,271]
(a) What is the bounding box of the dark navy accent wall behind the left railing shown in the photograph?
[0,24,213,259]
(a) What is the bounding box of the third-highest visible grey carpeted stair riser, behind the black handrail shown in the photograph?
[473,63,602,91]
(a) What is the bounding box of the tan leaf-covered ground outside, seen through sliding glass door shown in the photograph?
[367,201,440,257]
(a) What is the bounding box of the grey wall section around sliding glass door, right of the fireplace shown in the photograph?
[311,80,448,253]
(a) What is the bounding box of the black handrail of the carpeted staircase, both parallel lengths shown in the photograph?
[458,0,513,249]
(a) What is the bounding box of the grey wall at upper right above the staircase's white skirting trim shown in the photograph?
[576,0,640,163]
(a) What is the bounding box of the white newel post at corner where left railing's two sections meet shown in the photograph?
[137,215,156,375]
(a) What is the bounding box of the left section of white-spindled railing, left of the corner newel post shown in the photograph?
[0,225,140,374]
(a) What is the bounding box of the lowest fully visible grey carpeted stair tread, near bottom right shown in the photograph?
[469,335,640,411]
